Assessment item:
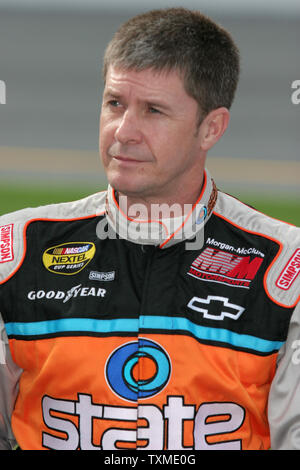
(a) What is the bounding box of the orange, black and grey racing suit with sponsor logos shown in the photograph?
[0,171,300,450]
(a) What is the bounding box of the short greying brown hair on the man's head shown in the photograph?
[103,8,240,122]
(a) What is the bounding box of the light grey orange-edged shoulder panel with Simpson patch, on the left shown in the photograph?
[0,191,106,284]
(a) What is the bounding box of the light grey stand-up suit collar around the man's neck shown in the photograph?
[105,171,218,249]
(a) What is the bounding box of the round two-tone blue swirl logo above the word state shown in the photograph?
[105,338,171,401]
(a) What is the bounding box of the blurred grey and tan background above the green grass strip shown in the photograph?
[0,0,300,192]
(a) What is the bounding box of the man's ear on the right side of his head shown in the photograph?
[199,107,230,152]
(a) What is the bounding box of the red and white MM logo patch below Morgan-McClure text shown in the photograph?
[188,248,263,289]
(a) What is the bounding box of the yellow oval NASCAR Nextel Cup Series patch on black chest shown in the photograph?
[43,242,96,276]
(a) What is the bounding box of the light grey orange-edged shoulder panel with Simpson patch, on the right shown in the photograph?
[214,192,300,307]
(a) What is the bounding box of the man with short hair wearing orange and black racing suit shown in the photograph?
[0,8,300,450]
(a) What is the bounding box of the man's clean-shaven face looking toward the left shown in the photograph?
[99,66,204,202]
